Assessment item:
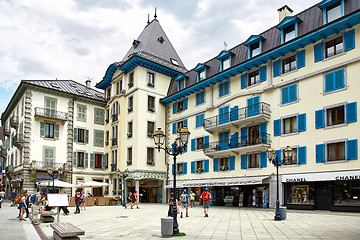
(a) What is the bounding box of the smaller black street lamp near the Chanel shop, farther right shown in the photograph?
[266,146,292,221]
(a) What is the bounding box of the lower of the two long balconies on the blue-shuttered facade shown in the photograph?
[204,133,271,157]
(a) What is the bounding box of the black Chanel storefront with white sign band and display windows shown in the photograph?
[282,171,360,212]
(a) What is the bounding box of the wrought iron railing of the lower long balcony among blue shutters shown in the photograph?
[204,133,271,154]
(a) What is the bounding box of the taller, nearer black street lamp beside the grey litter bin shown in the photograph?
[153,126,190,234]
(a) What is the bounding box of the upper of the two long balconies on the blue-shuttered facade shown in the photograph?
[204,102,271,133]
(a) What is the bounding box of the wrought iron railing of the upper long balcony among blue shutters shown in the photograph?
[204,102,271,129]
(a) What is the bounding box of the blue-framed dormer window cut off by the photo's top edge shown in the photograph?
[319,0,345,24]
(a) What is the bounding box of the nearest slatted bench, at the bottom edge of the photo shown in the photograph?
[50,223,85,240]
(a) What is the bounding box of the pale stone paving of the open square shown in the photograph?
[0,204,360,240]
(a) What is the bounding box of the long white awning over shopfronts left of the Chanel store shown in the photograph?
[165,176,269,188]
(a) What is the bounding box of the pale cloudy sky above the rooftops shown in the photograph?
[0,0,320,115]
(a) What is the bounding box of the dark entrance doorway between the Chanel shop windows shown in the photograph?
[315,182,333,210]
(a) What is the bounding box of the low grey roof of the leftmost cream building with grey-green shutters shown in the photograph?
[21,80,106,102]
